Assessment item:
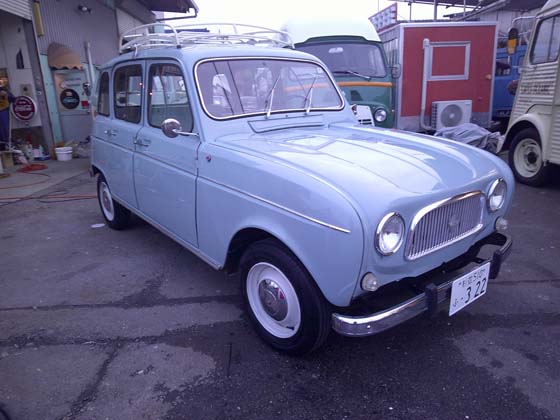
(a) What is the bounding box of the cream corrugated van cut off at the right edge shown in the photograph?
[505,0,560,186]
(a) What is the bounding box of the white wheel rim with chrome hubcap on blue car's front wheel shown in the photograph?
[247,263,301,338]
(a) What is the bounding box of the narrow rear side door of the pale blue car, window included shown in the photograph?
[105,61,144,207]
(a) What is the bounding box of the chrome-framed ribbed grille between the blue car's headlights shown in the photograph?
[406,192,485,260]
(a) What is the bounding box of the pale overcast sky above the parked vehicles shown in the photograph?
[166,0,472,28]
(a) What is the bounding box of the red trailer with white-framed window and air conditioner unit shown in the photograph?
[379,22,497,131]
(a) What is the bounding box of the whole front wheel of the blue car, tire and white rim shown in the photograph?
[240,239,331,355]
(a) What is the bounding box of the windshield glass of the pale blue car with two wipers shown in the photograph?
[196,58,344,119]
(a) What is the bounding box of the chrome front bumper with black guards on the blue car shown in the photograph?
[332,232,511,337]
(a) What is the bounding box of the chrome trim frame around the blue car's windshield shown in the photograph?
[193,56,345,121]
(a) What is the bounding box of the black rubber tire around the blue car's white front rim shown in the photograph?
[240,239,331,355]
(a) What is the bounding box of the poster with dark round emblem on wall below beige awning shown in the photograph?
[53,70,90,114]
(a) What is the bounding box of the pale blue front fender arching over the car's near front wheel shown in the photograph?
[197,146,364,306]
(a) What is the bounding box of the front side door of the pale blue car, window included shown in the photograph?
[134,60,200,246]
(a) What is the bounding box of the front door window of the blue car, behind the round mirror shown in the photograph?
[148,64,193,131]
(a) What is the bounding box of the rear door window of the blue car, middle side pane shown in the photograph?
[113,65,142,123]
